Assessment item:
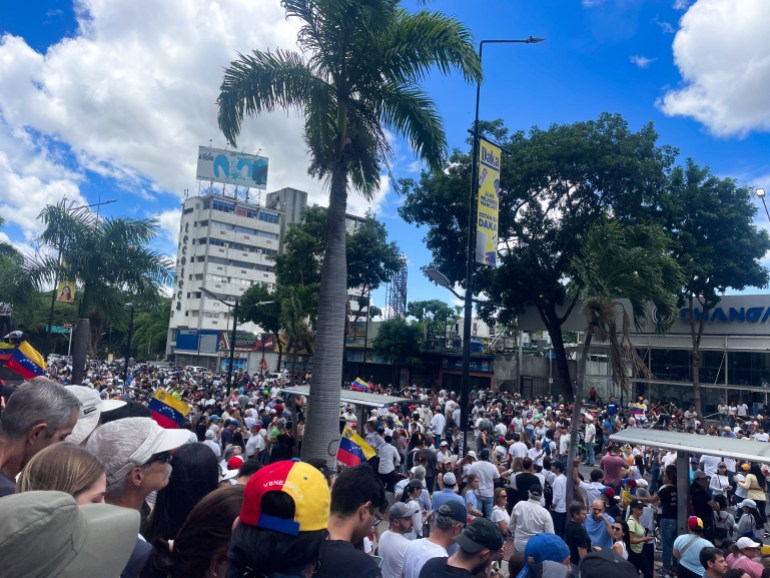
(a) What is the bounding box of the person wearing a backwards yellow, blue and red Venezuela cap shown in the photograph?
[227,461,331,578]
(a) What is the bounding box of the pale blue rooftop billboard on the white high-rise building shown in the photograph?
[196,147,267,189]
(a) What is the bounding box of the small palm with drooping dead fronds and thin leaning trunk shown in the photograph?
[565,221,682,504]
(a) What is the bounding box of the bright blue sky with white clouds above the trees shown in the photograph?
[0,0,770,312]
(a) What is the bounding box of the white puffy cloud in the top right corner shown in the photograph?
[658,0,770,137]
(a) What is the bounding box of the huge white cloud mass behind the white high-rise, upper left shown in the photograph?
[0,0,378,238]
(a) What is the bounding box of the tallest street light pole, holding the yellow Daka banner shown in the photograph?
[460,36,545,451]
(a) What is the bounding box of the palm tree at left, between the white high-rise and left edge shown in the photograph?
[33,200,171,383]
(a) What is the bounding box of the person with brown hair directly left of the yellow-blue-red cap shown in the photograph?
[142,485,244,578]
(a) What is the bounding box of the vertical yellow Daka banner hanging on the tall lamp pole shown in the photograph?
[476,138,500,267]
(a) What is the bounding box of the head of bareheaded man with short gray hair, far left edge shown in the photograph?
[0,377,80,497]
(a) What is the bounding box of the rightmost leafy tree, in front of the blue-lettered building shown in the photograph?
[663,160,770,412]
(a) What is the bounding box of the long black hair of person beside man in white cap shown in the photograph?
[142,443,219,544]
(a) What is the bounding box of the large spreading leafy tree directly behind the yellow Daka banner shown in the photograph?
[399,114,675,397]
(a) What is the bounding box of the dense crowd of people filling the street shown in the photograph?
[0,363,770,578]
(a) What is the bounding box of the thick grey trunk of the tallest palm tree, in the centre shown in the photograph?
[302,160,347,468]
